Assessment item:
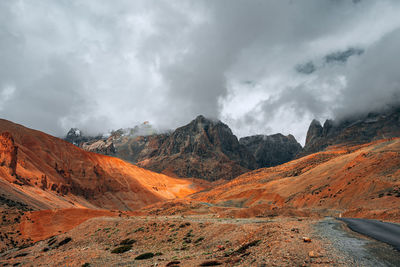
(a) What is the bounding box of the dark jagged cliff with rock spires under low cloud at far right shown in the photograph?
[299,108,400,156]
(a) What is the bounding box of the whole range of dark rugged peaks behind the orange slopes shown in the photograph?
[65,108,400,181]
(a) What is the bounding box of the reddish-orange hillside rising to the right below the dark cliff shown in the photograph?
[194,138,400,221]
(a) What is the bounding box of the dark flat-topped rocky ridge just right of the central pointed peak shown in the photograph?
[239,134,302,168]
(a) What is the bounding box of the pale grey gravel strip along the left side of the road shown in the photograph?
[314,217,400,266]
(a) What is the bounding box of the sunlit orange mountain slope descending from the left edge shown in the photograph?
[0,120,205,210]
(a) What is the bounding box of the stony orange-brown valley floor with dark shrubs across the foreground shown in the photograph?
[0,213,399,266]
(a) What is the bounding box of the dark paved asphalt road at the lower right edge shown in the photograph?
[337,218,400,251]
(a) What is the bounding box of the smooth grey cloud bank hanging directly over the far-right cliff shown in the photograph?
[335,28,400,118]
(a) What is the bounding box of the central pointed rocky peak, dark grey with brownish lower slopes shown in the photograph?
[137,116,256,181]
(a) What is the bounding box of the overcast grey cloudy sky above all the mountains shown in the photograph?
[0,0,400,144]
